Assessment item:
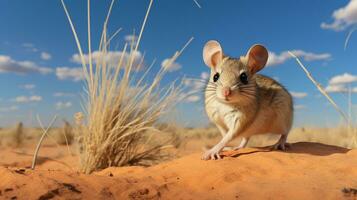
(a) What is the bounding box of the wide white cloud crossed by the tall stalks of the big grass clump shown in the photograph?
[71,51,143,70]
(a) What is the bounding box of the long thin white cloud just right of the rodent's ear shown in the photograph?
[267,50,331,66]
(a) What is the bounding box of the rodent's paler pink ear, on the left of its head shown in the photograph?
[203,40,223,67]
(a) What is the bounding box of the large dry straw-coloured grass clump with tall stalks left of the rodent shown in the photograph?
[62,0,186,173]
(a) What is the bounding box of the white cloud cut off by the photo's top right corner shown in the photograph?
[321,0,357,31]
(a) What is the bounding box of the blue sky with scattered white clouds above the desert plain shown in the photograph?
[0,0,357,126]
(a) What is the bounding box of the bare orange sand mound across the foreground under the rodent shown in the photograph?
[0,143,357,200]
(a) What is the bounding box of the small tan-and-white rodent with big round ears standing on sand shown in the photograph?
[202,40,293,160]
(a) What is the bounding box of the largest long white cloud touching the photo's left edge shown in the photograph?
[0,55,53,74]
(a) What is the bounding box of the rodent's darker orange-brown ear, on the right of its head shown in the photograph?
[246,44,268,74]
